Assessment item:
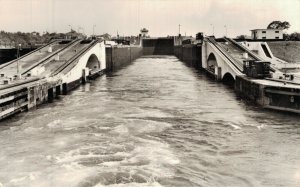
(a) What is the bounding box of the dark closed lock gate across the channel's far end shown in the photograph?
[142,38,174,55]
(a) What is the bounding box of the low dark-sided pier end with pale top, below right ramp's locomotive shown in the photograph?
[235,76,300,113]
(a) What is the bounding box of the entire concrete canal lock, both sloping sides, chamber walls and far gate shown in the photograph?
[0,33,300,119]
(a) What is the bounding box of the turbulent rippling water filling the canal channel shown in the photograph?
[0,56,300,187]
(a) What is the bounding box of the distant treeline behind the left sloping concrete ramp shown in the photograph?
[0,30,83,48]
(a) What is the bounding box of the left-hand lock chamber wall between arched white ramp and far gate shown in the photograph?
[106,46,143,71]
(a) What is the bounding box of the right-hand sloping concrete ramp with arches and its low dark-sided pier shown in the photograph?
[202,37,300,113]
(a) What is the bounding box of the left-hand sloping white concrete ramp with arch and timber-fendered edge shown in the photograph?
[0,39,106,119]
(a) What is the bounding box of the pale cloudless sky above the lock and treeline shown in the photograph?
[0,0,300,37]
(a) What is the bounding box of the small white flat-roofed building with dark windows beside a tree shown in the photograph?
[251,29,283,40]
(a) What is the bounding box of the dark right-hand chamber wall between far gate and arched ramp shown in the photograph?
[174,44,202,69]
